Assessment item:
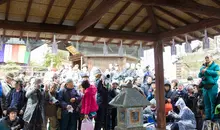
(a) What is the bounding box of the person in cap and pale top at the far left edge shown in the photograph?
[0,73,14,116]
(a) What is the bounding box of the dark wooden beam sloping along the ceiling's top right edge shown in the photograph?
[129,0,220,18]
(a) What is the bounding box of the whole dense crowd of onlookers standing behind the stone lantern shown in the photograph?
[0,56,220,130]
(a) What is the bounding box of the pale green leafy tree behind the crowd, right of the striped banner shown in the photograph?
[44,51,66,68]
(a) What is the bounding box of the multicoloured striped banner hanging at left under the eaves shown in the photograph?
[0,44,30,64]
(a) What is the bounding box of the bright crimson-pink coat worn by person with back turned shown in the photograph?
[81,85,98,115]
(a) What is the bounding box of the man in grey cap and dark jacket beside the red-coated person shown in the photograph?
[58,79,81,130]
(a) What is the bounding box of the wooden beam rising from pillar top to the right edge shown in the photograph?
[159,19,220,39]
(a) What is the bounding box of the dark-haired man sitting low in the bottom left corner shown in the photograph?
[0,108,23,130]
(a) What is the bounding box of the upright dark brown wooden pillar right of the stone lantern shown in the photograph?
[154,41,166,130]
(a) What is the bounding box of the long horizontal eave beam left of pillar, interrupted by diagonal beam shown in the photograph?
[0,20,157,41]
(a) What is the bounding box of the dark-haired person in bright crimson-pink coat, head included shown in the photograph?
[81,80,98,119]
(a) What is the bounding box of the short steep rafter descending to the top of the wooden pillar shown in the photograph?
[146,6,159,33]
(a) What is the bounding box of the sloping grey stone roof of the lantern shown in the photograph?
[109,88,150,108]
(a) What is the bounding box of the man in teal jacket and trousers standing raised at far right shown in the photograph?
[199,55,220,120]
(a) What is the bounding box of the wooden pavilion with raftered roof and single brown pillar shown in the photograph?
[0,0,220,129]
